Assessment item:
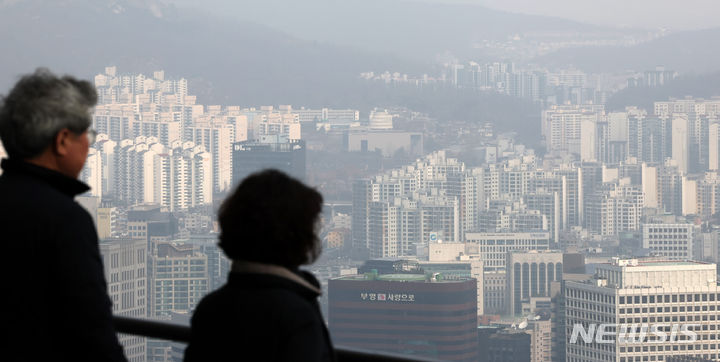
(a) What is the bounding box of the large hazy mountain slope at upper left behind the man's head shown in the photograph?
[0,0,422,105]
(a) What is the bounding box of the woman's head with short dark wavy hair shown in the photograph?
[219,170,323,268]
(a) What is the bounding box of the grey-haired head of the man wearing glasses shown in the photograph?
[0,68,97,177]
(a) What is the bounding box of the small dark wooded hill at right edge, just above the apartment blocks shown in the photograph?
[607,72,720,111]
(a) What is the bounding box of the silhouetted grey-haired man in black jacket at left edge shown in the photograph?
[0,69,125,361]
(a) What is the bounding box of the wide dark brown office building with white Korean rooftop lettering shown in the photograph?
[328,273,478,361]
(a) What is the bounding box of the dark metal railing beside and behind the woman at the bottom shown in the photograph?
[113,316,432,362]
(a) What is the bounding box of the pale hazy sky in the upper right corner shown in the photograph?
[422,0,720,30]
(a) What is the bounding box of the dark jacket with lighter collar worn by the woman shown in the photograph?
[185,263,335,362]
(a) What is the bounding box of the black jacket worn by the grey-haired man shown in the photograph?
[0,159,125,361]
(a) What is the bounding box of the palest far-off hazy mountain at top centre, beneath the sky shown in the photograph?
[174,0,614,60]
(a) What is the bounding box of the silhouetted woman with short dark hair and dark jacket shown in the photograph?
[185,170,334,361]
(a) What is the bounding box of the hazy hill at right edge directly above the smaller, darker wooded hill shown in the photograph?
[535,28,720,74]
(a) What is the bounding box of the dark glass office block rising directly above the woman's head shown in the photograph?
[232,136,305,185]
